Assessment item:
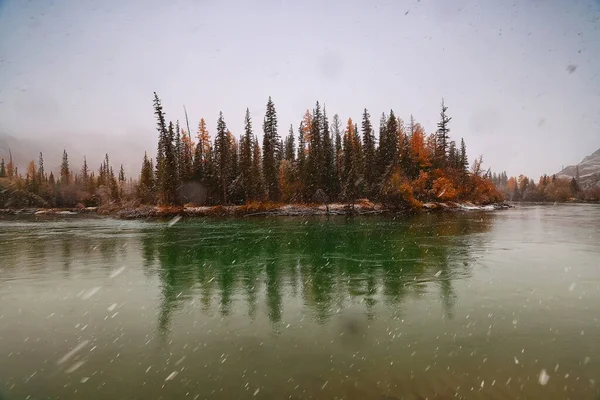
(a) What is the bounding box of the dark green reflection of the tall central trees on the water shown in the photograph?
[142,214,494,337]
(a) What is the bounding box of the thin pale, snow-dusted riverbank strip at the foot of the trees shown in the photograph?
[0,201,512,219]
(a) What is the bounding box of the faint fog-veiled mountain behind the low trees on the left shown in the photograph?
[0,132,156,177]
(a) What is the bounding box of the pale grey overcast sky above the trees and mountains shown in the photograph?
[0,0,600,176]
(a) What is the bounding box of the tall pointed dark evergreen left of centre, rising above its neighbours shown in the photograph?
[262,96,279,201]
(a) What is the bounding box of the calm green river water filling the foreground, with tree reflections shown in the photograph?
[0,205,600,400]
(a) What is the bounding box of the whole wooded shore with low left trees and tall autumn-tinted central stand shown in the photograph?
[0,93,503,216]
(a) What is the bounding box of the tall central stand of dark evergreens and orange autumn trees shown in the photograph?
[138,93,501,208]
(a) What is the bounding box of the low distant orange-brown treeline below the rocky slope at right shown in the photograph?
[490,172,600,202]
